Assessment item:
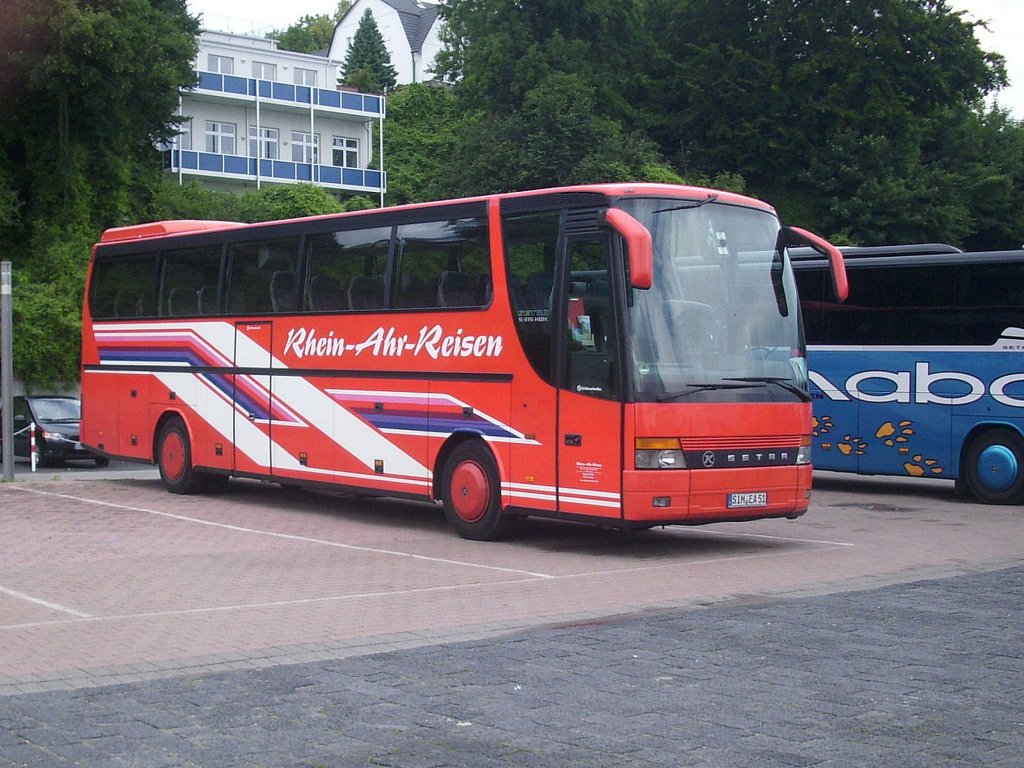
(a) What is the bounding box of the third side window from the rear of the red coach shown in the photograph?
[226,239,299,314]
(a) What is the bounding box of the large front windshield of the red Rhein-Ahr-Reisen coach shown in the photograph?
[622,195,809,402]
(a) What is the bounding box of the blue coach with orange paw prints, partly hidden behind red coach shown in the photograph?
[793,245,1024,504]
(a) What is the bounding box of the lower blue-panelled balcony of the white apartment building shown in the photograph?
[163,150,387,194]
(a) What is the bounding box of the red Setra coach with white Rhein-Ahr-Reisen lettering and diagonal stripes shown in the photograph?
[81,184,845,540]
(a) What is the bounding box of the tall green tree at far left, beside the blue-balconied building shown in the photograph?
[0,0,199,382]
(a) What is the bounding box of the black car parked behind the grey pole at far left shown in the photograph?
[1,395,111,467]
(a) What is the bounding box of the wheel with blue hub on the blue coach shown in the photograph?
[963,428,1024,504]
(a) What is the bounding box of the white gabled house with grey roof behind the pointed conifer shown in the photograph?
[328,0,441,85]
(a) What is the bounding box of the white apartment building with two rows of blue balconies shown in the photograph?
[164,31,386,203]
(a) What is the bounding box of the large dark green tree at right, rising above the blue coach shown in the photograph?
[645,0,1019,243]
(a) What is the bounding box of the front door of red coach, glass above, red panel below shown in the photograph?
[555,232,623,517]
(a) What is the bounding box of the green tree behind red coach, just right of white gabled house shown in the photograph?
[435,0,678,194]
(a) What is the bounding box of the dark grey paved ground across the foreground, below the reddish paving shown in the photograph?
[0,567,1024,768]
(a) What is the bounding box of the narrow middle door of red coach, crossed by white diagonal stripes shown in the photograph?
[231,321,273,474]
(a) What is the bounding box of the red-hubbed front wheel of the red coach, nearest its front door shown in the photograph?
[441,440,511,542]
